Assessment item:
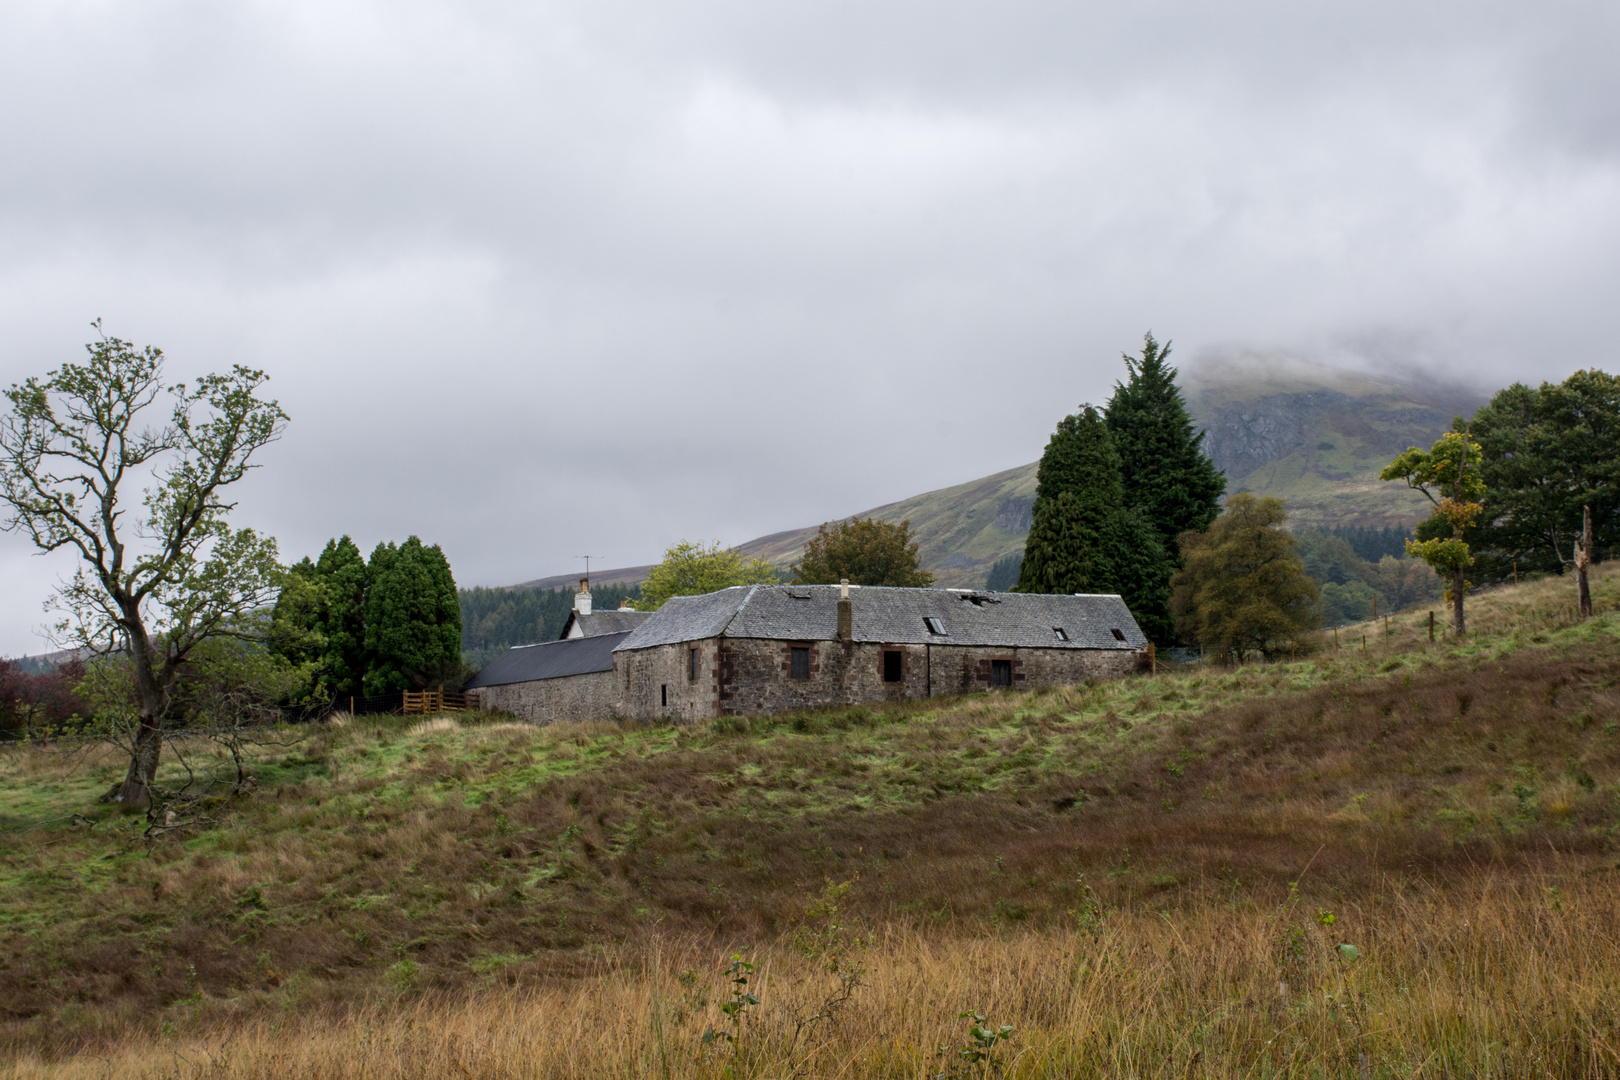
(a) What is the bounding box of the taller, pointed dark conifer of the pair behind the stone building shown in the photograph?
[1108,334,1226,560]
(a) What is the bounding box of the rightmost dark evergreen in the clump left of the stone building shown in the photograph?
[365,536,462,695]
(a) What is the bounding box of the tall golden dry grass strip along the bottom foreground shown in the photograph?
[0,873,1620,1080]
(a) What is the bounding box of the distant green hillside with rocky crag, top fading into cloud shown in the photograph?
[739,359,1484,588]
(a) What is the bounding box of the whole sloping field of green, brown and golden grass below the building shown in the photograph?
[0,572,1620,1077]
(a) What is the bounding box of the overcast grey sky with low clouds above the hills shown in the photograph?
[0,0,1620,654]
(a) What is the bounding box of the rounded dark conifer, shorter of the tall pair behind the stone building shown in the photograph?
[1014,405,1175,641]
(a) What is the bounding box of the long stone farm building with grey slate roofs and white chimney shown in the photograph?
[467,583,1150,724]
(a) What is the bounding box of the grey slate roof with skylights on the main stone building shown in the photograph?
[616,585,1147,651]
